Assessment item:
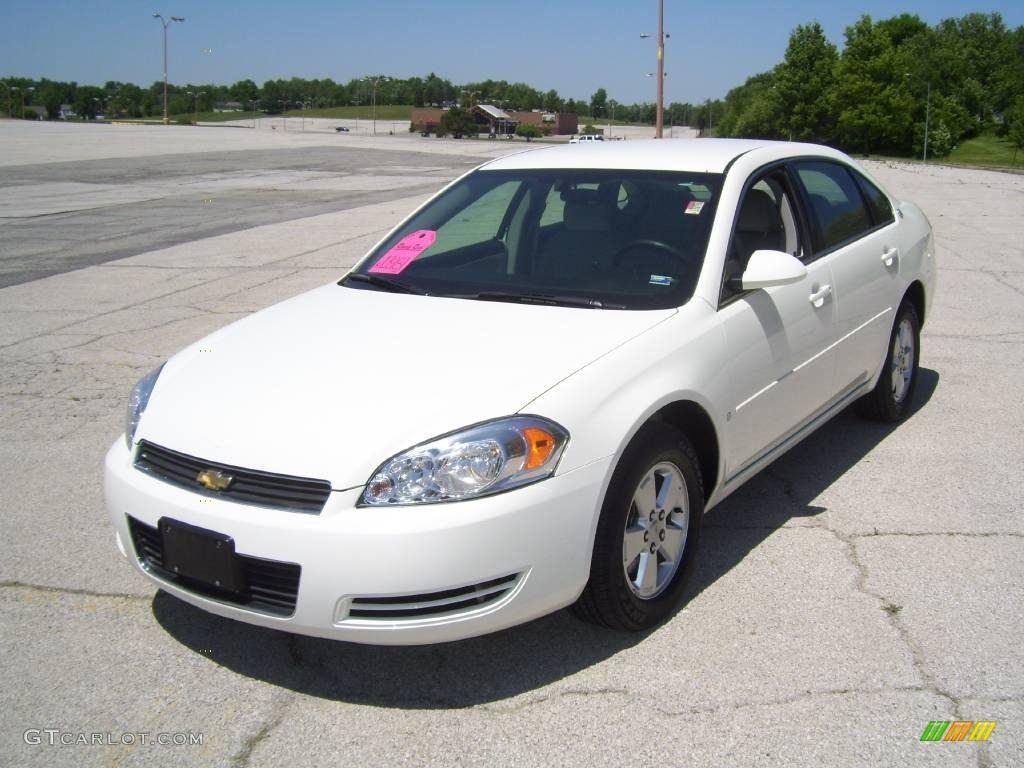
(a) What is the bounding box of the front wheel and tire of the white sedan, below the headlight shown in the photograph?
[572,423,705,632]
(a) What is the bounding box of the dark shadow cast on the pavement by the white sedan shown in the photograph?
[153,369,939,709]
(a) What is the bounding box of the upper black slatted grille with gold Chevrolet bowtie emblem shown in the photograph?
[135,440,331,514]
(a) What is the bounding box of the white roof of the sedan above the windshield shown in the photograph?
[481,138,849,173]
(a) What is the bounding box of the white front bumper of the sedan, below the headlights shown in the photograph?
[105,438,611,645]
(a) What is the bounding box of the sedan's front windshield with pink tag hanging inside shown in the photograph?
[344,170,721,309]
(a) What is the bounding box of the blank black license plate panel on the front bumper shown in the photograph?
[159,517,246,595]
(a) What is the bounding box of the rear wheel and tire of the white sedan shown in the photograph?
[857,301,921,422]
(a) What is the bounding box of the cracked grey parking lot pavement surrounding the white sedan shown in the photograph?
[0,121,1024,768]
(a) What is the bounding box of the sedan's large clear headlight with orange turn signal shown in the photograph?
[361,416,569,506]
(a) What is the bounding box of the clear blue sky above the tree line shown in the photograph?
[0,0,1024,102]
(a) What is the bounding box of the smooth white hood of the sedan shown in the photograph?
[136,285,676,489]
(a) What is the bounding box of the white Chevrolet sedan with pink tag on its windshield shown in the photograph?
[105,139,936,644]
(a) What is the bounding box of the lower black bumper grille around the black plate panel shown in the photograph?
[128,515,302,616]
